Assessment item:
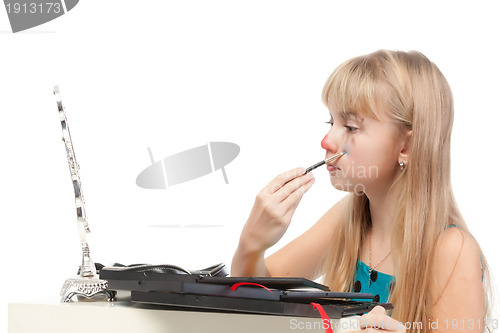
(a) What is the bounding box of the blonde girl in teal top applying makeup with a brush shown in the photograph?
[231,50,488,332]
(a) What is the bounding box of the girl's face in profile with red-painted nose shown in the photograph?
[321,110,405,195]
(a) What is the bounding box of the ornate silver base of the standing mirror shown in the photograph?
[61,276,116,303]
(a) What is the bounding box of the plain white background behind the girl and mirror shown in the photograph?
[0,0,500,329]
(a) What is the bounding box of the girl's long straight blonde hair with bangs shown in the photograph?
[322,50,488,332]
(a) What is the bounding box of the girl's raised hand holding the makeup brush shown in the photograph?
[240,168,314,253]
